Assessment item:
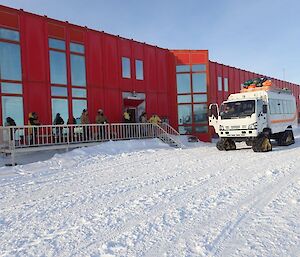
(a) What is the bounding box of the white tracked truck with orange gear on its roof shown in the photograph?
[208,86,297,152]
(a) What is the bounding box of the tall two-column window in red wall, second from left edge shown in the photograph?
[49,38,87,123]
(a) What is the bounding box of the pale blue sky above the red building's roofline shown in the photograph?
[0,0,300,84]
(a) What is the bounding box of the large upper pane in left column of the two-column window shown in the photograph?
[50,50,67,85]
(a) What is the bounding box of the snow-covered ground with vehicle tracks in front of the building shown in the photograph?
[0,130,300,257]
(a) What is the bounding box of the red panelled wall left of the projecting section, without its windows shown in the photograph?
[0,6,175,128]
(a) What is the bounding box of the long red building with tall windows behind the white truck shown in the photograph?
[0,6,300,141]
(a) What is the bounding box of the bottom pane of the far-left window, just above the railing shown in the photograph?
[2,96,24,126]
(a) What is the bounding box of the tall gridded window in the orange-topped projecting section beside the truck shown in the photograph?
[176,64,208,134]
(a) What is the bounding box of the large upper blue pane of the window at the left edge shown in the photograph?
[0,42,22,81]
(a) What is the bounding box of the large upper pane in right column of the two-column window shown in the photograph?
[71,54,86,86]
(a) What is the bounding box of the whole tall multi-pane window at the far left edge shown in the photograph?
[0,28,24,126]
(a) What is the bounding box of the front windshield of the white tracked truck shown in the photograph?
[220,100,255,119]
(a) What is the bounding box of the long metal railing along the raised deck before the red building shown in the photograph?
[0,123,175,151]
